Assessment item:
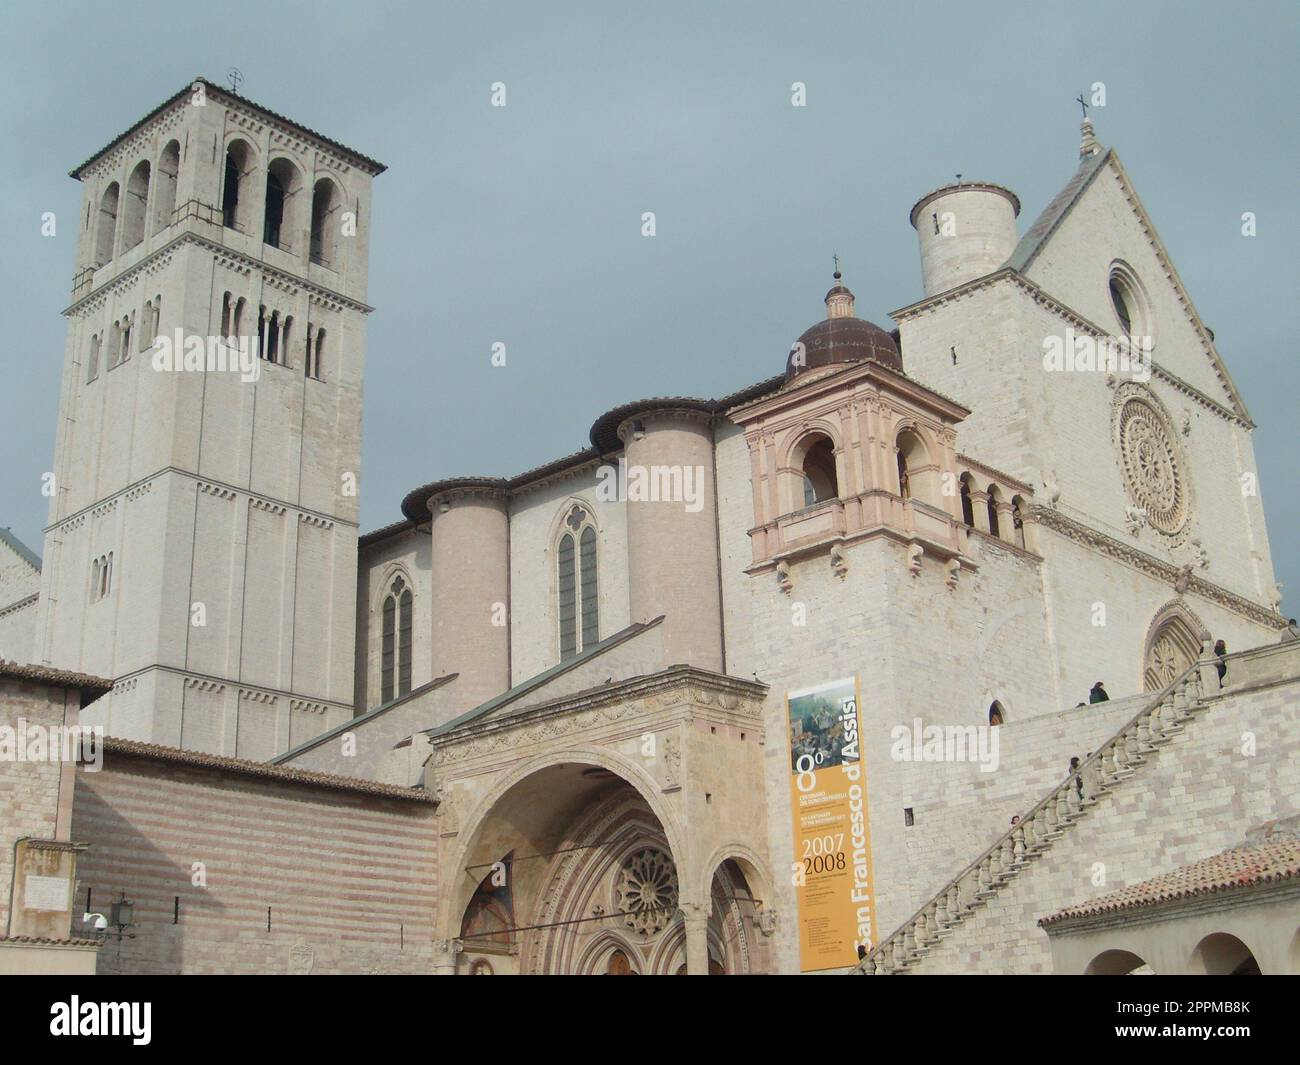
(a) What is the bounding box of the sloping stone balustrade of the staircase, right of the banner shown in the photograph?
[854,645,1249,975]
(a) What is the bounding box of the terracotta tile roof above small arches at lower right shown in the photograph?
[1039,839,1300,927]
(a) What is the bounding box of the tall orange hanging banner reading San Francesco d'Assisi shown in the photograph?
[785,676,876,973]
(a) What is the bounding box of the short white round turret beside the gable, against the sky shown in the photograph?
[911,181,1021,295]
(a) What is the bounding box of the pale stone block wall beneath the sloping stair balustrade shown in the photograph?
[909,649,1300,974]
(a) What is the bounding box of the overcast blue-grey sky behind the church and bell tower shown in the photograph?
[0,0,1300,612]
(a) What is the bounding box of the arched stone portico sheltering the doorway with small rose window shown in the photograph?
[430,667,772,974]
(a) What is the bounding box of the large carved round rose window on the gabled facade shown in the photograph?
[1115,384,1191,540]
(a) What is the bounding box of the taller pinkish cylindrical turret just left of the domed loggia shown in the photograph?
[619,407,723,672]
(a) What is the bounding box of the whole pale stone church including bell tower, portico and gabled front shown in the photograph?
[0,81,1300,974]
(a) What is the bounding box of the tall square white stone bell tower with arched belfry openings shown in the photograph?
[36,78,384,758]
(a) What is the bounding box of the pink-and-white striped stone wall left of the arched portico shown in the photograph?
[73,741,437,974]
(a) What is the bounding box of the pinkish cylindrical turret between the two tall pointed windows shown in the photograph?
[429,479,510,710]
